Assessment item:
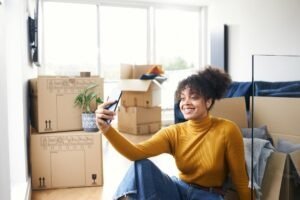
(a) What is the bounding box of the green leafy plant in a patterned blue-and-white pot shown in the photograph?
[74,83,103,132]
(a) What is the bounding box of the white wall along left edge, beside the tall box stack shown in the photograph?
[0,0,37,200]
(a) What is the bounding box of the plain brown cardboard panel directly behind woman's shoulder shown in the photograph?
[210,97,248,128]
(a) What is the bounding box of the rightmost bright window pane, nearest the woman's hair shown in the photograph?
[155,9,200,108]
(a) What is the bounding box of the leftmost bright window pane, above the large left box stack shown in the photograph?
[43,2,98,75]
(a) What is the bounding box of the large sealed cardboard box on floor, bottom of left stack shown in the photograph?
[30,131,103,189]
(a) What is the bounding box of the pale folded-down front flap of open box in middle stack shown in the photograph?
[119,79,153,92]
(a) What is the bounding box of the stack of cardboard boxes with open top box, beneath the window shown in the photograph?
[118,65,161,134]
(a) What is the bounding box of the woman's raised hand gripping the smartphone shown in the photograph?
[95,101,116,133]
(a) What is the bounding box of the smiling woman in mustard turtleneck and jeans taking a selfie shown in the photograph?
[96,66,251,200]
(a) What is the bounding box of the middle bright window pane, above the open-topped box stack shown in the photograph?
[100,6,147,80]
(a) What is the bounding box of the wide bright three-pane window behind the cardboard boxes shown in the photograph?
[40,0,201,122]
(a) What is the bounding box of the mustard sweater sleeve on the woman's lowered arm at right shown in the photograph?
[226,125,251,200]
